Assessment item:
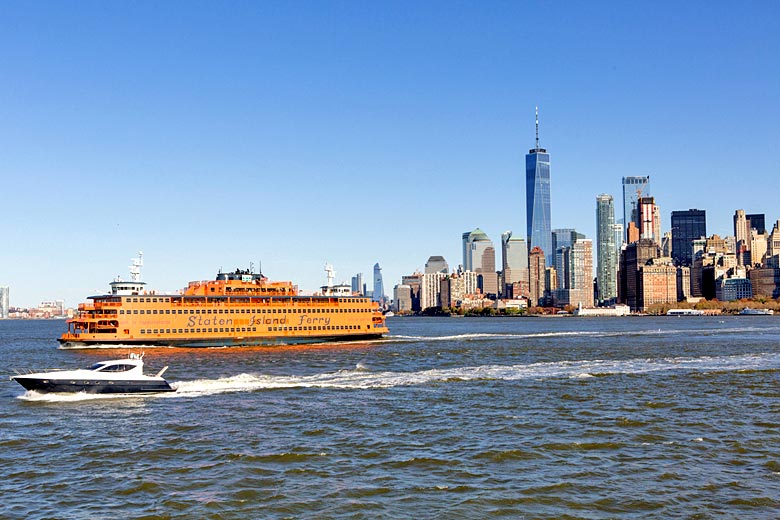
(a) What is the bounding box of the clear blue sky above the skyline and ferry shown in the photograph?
[0,1,780,306]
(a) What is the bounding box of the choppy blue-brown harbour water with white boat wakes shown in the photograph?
[0,316,780,519]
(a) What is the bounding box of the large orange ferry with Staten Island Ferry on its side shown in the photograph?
[58,254,389,348]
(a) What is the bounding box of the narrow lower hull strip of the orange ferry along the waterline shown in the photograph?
[57,333,382,349]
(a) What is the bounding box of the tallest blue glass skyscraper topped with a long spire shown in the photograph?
[525,107,554,265]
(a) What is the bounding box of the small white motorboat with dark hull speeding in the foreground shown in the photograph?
[11,354,176,394]
